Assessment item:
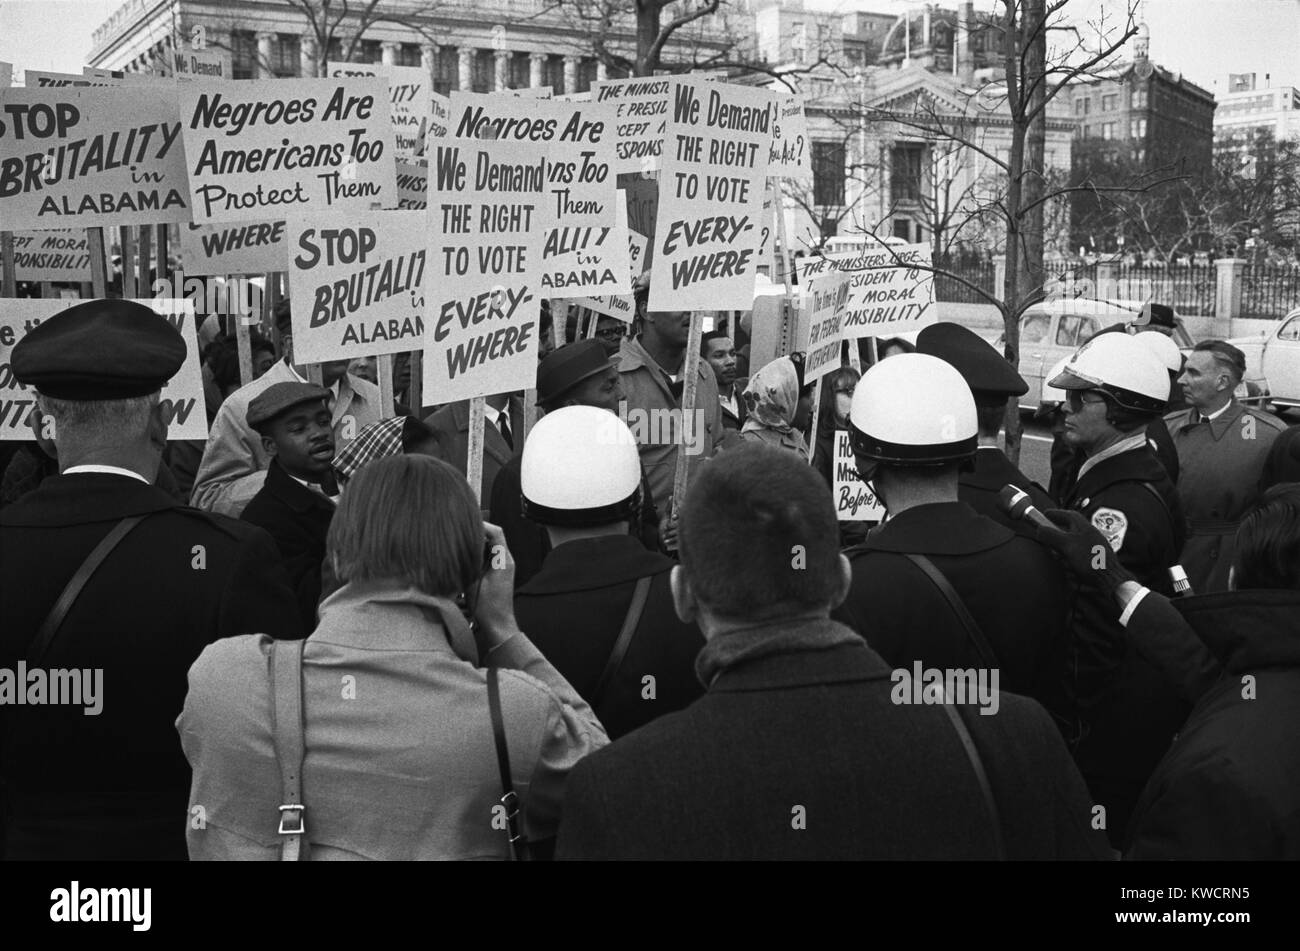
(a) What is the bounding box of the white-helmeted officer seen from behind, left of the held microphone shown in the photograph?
[833,353,1073,730]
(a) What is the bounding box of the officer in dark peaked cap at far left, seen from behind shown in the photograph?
[0,300,303,860]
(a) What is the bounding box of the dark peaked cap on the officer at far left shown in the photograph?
[9,300,186,401]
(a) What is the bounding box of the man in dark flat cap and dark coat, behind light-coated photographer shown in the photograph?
[239,383,338,630]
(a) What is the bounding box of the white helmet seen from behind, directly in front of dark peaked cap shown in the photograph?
[849,353,979,465]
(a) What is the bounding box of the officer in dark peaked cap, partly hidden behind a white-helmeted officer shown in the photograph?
[917,322,1054,533]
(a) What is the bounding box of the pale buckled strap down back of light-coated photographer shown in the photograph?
[270,640,307,861]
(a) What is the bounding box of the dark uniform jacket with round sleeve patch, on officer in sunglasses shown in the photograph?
[1065,431,1190,844]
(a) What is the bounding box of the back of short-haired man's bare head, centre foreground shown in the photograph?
[679,444,842,621]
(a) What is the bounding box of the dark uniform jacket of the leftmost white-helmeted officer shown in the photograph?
[515,535,705,739]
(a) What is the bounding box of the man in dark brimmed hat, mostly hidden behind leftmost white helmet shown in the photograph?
[489,339,659,589]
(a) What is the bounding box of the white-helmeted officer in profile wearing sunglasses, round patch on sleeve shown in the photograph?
[1048,334,1190,846]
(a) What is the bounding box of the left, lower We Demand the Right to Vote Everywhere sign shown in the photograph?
[424,139,547,403]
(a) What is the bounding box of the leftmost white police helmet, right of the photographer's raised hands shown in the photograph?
[520,407,641,527]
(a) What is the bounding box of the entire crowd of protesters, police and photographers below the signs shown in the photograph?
[0,288,1300,860]
